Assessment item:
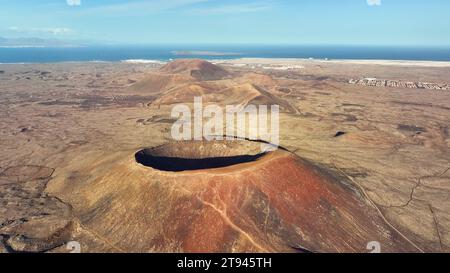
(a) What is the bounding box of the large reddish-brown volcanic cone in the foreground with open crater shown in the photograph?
[48,140,416,252]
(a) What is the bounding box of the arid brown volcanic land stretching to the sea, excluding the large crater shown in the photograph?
[0,59,450,252]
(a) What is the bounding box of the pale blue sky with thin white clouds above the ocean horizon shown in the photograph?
[0,0,450,46]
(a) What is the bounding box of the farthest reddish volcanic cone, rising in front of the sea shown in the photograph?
[160,59,230,81]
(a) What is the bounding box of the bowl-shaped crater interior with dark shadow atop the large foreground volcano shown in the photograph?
[135,140,267,172]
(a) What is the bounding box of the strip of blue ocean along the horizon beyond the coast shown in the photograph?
[0,45,450,63]
